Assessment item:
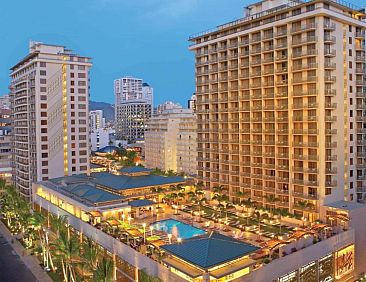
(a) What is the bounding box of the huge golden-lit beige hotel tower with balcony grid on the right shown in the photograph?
[190,0,366,220]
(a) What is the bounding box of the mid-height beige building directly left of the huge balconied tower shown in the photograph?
[145,109,197,175]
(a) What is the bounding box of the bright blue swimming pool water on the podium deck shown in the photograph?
[151,219,206,239]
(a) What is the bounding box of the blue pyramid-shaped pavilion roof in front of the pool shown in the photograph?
[161,232,259,269]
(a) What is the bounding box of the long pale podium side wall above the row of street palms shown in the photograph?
[33,195,185,282]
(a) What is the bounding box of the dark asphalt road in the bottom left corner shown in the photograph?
[0,233,37,282]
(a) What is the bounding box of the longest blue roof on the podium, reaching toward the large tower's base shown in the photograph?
[91,172,185,190]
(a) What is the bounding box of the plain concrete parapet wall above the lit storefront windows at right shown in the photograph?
[240,230,355,282]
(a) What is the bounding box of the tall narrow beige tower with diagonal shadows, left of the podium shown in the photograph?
[10,42,92,197]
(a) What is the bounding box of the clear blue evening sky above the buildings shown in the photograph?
[0,0,365,106]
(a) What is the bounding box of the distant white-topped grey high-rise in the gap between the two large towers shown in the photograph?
[114,77,153,142]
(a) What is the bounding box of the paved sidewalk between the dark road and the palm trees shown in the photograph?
[0,221,52,282]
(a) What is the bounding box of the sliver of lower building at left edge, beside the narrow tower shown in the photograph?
[0,109,12,182]
